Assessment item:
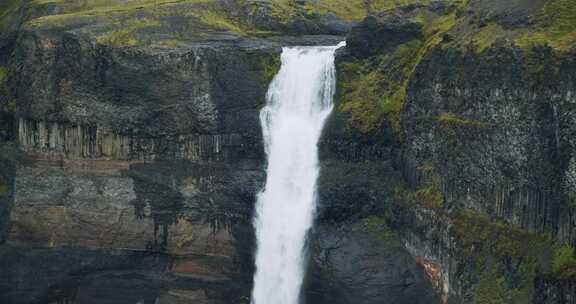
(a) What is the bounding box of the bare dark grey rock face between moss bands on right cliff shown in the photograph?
[403,48,576,243]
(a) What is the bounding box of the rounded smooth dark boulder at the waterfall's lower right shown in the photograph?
[308,226,438,304]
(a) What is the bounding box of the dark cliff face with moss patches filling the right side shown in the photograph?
[328,1,575,303]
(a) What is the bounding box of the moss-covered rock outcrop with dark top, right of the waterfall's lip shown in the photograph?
[337,5,459,134]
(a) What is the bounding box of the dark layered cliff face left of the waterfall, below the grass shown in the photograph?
[0,4,274,303]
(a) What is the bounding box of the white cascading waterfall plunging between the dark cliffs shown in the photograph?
[252,43,344,304]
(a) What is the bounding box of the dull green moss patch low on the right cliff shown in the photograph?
[453,210,554,304]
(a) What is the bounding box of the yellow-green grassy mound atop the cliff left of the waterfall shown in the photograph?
[27,0,264,47]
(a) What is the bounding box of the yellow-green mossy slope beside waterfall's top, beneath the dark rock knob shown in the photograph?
[338,10,460,133]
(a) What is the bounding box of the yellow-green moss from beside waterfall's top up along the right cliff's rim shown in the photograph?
[338,0,576,133]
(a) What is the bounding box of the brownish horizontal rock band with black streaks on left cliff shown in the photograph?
[10,162,263,255]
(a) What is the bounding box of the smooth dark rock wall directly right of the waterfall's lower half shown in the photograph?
[312,116,439,304]
